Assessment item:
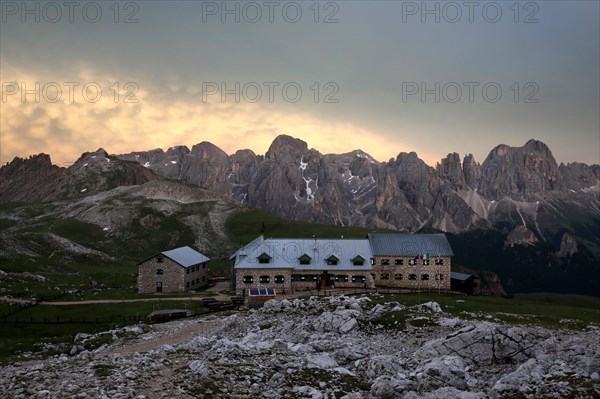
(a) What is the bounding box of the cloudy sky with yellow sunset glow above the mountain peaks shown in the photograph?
[0,1,600,165]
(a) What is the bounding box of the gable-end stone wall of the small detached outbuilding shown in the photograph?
[138,255,185,293]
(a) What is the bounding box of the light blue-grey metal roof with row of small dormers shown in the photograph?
[235,238,373,271]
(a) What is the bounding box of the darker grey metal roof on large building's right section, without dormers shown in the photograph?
[369,233,454,256]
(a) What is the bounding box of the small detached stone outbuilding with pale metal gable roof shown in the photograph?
[138,246,210,293]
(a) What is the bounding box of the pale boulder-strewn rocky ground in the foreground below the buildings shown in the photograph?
[0,296,600,399]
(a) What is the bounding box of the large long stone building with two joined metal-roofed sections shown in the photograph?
[230,234,454,294]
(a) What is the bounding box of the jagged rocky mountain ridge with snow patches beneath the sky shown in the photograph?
[0,139,600,246]
